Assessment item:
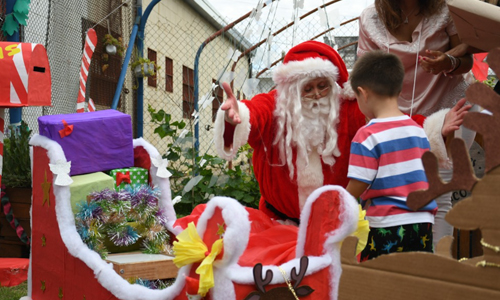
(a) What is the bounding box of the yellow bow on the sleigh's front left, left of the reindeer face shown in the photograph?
[173,222,223,297]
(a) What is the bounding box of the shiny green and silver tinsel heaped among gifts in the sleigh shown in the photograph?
[75,185,171,259]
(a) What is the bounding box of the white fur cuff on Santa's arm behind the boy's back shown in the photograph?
[424,108,452,169]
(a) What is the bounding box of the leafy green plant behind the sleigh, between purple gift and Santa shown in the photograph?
[148,105,260,217]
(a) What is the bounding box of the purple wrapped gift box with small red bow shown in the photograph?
[38,109,134,175]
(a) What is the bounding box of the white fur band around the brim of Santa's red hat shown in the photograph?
[273,58,339,85]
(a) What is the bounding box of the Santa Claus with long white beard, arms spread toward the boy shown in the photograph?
[214,41,456,223]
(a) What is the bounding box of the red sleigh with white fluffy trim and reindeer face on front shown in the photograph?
[26,129,358,300]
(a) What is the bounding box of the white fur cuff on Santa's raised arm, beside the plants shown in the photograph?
[214,102,250,160]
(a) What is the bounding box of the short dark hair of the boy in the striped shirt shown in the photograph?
[350,50,405,97]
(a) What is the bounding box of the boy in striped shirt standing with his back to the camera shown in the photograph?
[346,51,437,261]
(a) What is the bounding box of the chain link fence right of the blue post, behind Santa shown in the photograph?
[143,1,358,162]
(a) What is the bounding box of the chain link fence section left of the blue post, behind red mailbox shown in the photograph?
[0,0,135,132]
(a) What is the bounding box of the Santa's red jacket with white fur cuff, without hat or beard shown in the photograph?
[214,90,444,220]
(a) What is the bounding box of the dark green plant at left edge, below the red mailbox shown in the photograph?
[2,121,31,187]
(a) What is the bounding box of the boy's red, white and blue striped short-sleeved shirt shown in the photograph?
[347,115,437,228]
